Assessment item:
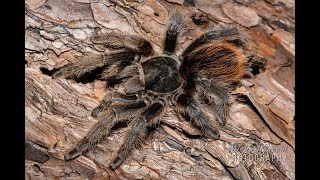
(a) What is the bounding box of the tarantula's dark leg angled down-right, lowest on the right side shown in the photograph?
[176,94,220,139]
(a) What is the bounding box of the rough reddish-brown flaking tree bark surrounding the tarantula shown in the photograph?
[25,0,295,179]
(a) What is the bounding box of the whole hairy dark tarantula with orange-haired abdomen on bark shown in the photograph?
[52,13,245,169]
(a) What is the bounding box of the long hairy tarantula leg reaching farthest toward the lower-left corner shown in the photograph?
[64,101,146,160]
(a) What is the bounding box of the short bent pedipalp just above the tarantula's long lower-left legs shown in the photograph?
[91,91,137,117]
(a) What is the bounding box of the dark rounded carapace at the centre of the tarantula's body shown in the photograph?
[142,56,181,93]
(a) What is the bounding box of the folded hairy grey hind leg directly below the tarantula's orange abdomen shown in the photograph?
[195,78,230,125]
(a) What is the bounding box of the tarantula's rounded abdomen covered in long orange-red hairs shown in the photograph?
[180,42,245,82]
